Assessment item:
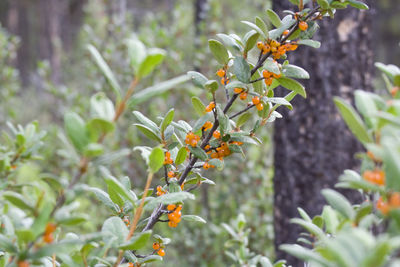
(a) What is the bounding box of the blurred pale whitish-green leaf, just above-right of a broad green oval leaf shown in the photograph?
[90,93,115,121]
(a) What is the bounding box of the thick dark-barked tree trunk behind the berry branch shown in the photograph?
[274,0,373,266]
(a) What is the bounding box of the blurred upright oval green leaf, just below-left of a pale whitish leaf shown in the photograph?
[64,112,89,152]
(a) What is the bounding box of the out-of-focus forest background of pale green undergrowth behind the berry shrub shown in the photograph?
[0,0,400,266]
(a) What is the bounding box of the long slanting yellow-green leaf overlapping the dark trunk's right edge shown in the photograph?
[333,97,373,144]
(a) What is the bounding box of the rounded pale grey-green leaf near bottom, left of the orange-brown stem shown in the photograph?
[101,216,129,245]
